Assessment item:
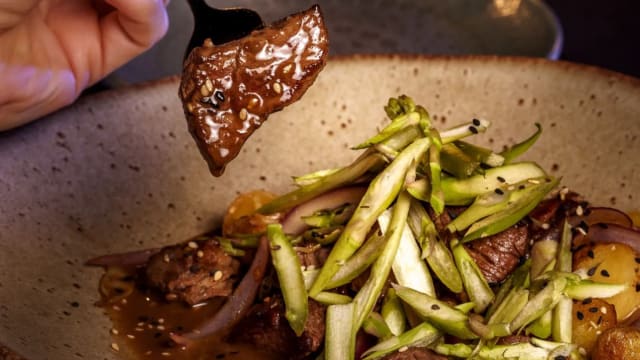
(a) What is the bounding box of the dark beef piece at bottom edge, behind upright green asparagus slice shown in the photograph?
[231,296,325,359]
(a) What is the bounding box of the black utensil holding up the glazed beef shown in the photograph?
[184,0,264,59]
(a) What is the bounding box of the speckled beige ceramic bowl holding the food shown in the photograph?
[0,56,640,360]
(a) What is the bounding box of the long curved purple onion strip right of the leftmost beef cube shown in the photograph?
[170,236,269,345]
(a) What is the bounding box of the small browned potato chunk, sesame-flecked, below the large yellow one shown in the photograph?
[571,298,618,353]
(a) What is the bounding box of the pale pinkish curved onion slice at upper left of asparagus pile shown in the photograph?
[282,187,367,236]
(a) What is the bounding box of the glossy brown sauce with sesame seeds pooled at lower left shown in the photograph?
[98,269,276,360]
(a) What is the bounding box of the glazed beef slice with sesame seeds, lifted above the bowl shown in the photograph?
[179,6,329,176]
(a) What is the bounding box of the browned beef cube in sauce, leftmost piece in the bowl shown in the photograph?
[145,239,240,305]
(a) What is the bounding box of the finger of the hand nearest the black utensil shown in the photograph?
[100,0,169,74]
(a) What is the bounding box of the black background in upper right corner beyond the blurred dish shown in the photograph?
[545,0,640,78]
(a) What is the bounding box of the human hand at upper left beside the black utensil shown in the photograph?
[0,0,168,130]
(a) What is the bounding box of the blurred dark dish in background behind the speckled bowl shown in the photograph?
[105,0,562,86]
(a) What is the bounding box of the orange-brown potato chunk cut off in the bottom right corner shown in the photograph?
[591,326,640,360]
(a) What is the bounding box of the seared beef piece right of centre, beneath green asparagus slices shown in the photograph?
[465,224,529,283]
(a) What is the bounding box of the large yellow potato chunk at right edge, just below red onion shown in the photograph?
[573,243,640,323]
